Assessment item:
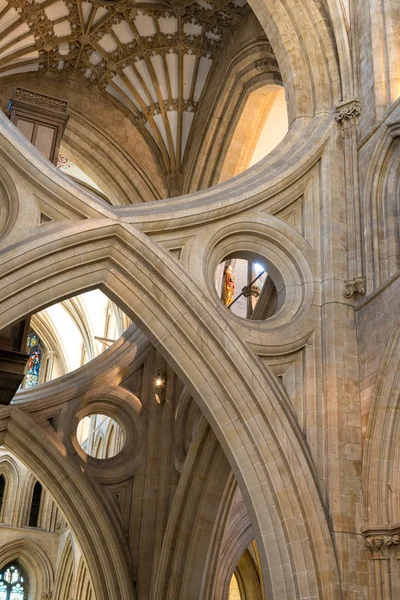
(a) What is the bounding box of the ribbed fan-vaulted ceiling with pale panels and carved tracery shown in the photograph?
[0,0,250,173]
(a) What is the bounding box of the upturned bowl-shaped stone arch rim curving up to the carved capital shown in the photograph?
[0,106,336,237]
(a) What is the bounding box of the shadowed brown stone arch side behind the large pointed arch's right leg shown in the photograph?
[151,417,236,600]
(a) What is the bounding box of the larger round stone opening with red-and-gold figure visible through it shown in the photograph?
[215,253,283,320]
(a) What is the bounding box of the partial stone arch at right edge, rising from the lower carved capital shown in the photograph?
[363,318,400,529]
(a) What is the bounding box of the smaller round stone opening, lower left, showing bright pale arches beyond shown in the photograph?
[76,414,125,459]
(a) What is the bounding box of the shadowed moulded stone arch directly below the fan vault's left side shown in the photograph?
[0,73,167,204]
